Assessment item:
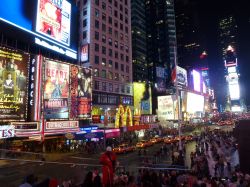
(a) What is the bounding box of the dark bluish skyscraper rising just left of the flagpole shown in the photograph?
[145,0,177,112]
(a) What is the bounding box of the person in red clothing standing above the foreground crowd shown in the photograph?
[100,146,116,187]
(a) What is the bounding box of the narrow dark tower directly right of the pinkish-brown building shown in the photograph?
[131,0,148,82]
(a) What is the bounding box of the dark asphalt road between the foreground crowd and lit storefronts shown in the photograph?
[0,144,188,187]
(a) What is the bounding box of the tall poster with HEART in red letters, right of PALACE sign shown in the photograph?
[44,59,69,119]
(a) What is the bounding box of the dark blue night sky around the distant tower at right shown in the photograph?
[186,0,250,106]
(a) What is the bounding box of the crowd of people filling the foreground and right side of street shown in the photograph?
[19,131,250,187]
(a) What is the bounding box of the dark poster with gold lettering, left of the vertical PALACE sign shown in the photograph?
[0,48,29,121]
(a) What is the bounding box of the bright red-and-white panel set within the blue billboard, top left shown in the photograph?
[36,0,71,46]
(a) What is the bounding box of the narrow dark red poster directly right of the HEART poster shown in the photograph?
[70,66,92,119]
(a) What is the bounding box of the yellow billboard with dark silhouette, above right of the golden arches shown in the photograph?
[133,82,152,115]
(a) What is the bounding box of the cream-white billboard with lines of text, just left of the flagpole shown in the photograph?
[157,95,178,121]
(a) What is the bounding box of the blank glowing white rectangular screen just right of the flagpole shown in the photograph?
[187,92,204,114]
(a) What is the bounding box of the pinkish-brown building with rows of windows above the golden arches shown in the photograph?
[79,0,133,121]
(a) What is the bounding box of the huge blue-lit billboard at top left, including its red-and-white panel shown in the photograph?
[0,0,78,59]
